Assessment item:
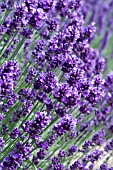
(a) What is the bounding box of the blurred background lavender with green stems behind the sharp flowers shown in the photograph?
[82,0,113,73]
